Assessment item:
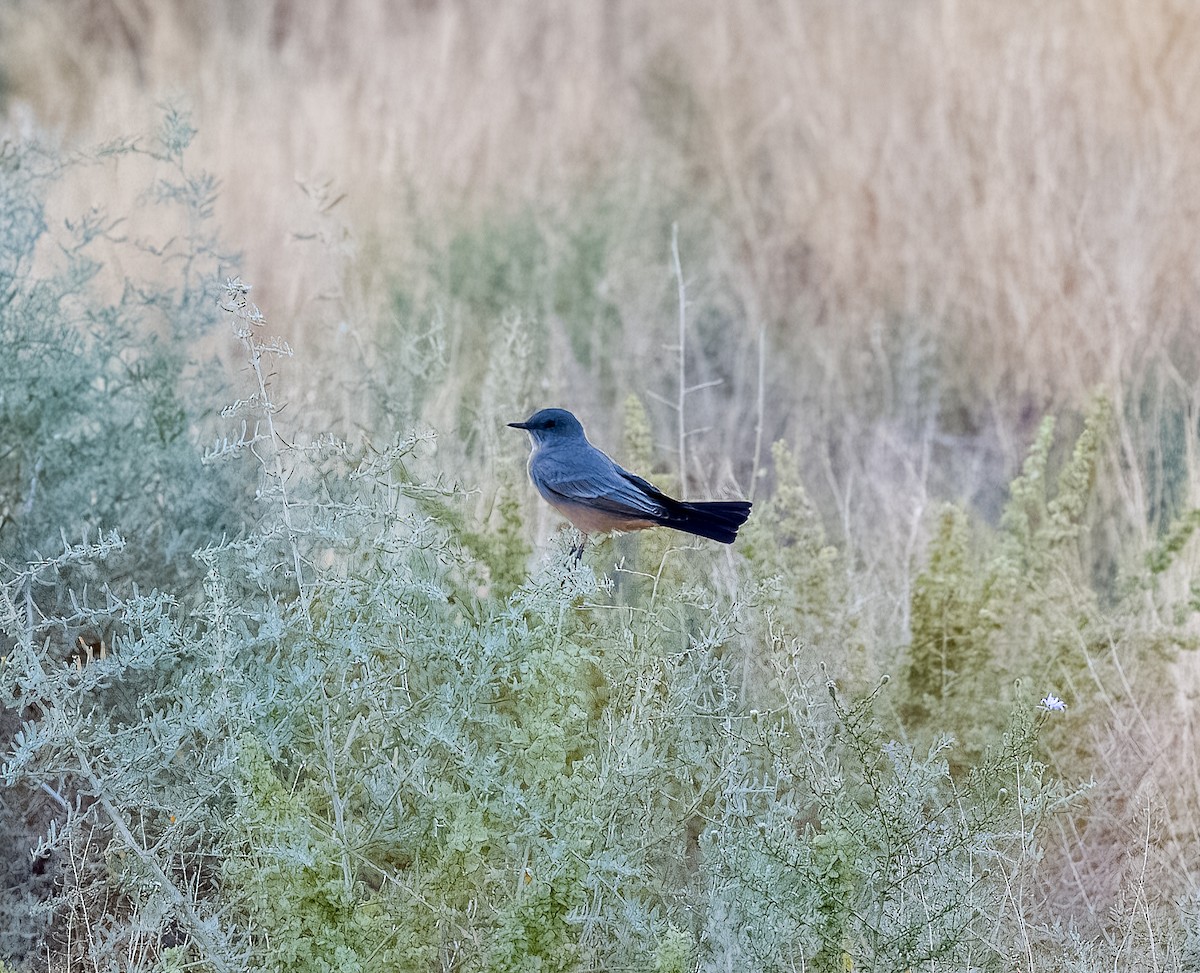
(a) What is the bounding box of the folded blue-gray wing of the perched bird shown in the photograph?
[530,450,667,517]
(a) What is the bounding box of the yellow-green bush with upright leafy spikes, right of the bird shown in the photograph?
[901,398,1132,756]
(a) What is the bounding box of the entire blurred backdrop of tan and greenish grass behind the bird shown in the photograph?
[7,0,1200,964]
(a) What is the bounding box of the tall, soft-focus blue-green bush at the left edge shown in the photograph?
[0,112,245,592]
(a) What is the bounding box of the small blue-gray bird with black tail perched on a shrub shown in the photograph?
[509,409,751,559]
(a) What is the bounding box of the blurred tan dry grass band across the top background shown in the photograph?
[4,0,1200,436]
